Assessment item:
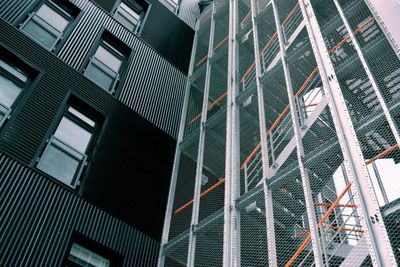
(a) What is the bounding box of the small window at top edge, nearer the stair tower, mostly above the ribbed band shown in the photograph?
[114,1,148,33]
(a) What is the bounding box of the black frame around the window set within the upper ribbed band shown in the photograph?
[79,28,134,98]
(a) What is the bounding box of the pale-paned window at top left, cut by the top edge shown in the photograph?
[21,1,76,51]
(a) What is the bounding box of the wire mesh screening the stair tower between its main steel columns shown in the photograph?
[160,0,400,266]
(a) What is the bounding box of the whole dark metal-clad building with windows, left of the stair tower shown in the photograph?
[0,0,197,266]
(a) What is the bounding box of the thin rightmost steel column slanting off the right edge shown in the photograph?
[334,0,400,149]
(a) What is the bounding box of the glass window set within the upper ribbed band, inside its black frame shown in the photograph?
[84,34,127,94]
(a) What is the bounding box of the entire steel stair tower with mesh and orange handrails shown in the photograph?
[158,0,400,266]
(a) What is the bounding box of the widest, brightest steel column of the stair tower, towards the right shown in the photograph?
[299,0,397,266]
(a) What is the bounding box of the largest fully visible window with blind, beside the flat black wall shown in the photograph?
[37,100,100,188]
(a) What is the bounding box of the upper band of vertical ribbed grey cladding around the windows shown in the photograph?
[0,0,186,137]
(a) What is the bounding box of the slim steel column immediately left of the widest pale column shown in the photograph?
[271,0,323,266]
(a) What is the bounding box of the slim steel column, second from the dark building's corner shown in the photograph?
[186,2,216,267]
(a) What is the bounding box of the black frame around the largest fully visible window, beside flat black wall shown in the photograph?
[35,96,106,191]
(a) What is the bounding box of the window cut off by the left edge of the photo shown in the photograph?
[0,53,31,126]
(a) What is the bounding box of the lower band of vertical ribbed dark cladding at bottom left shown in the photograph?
[0,154,158,266]
